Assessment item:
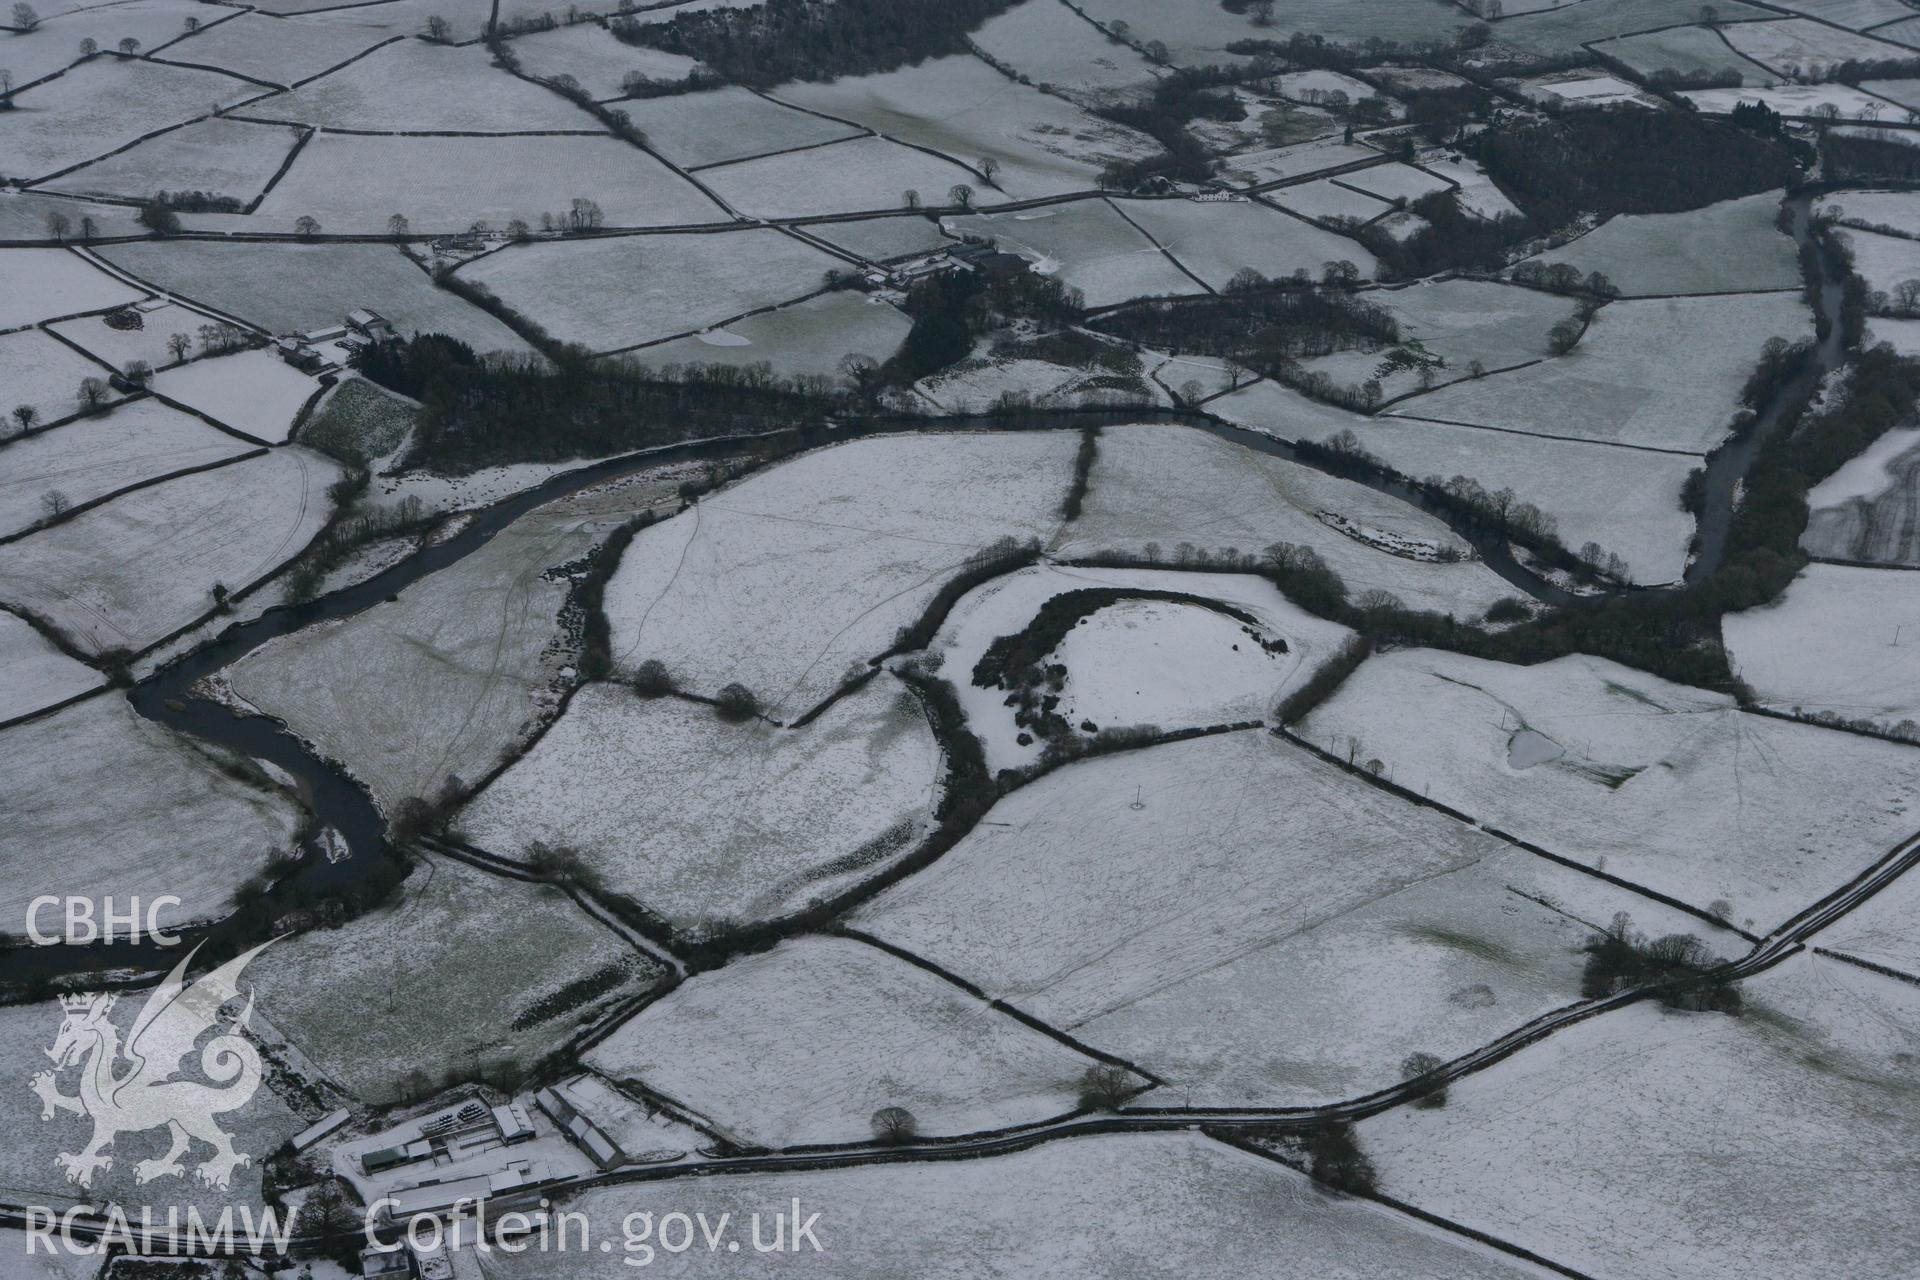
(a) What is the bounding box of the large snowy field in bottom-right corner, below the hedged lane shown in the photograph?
[1359,956,1920,1280]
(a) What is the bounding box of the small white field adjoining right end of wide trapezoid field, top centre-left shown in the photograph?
[701,136,1002,219]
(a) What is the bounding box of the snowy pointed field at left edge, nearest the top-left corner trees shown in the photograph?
[0,58,267,180]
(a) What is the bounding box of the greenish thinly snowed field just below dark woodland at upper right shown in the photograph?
[1536,192,1801,297]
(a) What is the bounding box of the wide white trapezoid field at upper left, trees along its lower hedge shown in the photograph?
[240,134,726,234]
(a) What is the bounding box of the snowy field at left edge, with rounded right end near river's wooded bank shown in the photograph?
[0,445,342,652]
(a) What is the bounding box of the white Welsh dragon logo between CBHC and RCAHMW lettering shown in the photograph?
[33,942,267,1188]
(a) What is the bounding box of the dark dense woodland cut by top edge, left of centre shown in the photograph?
[612,0,1012,88]
